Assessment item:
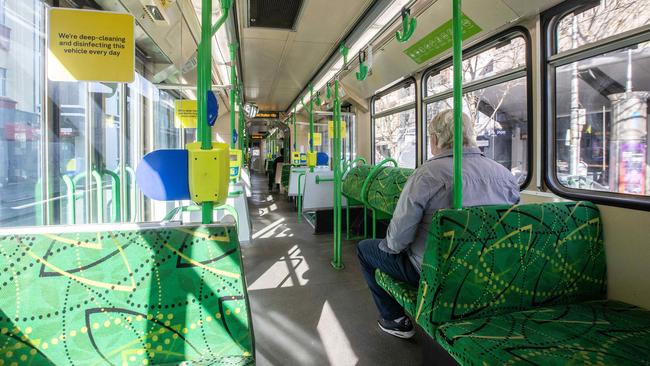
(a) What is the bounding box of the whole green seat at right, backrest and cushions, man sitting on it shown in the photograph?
[375,202,650,365]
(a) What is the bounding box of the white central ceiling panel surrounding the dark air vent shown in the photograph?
[237,0,372,111]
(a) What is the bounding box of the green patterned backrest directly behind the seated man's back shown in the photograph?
[416,202,607,335]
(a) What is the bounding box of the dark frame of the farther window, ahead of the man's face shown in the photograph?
[370,76,420,168]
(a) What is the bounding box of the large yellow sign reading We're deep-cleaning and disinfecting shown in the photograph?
[47,8,135,83]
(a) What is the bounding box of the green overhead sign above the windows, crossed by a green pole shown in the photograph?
[404,14,482,64]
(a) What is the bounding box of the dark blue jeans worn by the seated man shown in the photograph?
[357,239,420,320]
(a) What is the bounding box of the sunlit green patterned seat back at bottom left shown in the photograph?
[0,226,255,366]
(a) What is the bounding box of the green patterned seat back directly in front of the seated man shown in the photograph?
[368,167,414,216]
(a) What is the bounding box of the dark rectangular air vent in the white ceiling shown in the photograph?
[248,0,304,30]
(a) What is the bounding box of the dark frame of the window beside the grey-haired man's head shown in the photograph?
[418,26,535,191]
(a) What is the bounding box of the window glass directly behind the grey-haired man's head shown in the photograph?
[422,30,530,186]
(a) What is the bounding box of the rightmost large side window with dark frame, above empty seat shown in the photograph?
[544,0,650,207]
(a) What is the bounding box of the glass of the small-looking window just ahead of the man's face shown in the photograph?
[372,80,417,168]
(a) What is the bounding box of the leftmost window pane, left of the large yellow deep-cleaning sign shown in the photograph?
[0,1,45,227]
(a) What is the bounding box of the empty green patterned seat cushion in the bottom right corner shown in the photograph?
[435,301,650,365]
